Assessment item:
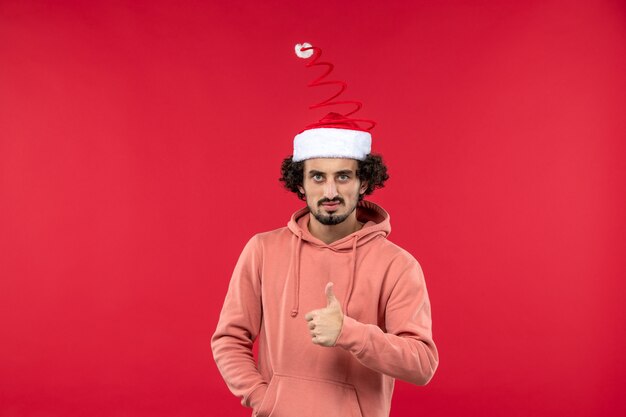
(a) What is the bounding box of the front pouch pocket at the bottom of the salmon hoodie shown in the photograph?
[256,374,362,417]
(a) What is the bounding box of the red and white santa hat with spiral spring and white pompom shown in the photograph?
[292,43,376,162]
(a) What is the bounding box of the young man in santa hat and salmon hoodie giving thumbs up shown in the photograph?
[212,43,439,417]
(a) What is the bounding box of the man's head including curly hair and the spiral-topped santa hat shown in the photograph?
[280,42,382,225]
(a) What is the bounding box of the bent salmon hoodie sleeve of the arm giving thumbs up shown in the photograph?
[335,257,439,385]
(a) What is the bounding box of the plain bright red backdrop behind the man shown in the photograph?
[0,0,626,417]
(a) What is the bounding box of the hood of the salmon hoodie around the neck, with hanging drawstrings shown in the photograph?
[287,200,391,317]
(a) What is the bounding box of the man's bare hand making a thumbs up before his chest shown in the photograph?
[304,282,343,347]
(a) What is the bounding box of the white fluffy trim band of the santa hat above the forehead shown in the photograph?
[292,127,372,162]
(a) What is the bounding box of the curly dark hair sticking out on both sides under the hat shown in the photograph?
[279,153,389,201]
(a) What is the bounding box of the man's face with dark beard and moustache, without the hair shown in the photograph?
[298,158,367,225]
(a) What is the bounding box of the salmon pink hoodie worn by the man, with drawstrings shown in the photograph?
[211,201,439,417]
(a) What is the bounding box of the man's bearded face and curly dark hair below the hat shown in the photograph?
[280,154,389,225]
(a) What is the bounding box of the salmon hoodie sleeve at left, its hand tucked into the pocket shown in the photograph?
[211,236,267,410]
